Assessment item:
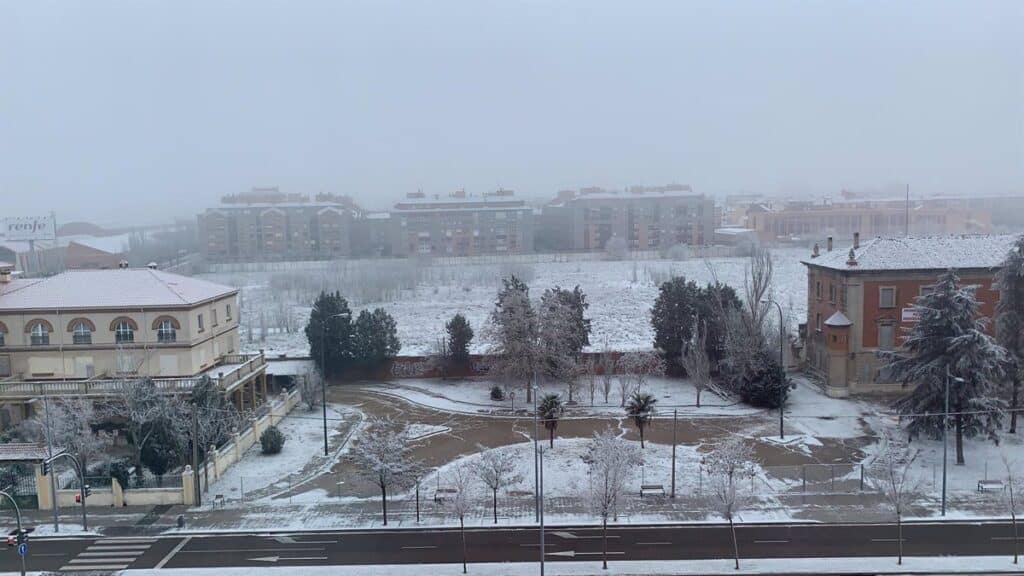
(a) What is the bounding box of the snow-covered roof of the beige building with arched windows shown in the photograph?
[0,269,238,311]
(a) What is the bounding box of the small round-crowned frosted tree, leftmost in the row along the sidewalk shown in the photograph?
[352,417,421,526]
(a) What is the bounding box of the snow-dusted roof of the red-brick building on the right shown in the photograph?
[801,234,1017,272]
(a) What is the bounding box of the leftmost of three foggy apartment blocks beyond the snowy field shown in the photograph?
[199,188,359,262]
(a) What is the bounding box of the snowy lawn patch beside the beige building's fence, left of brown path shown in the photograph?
[209,404,353,499]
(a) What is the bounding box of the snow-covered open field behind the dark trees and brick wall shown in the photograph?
[204,248,809,355]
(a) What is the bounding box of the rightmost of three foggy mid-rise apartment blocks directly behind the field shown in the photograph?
[542,184,718,251]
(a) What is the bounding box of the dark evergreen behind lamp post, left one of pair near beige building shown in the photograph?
[306,292,353,380]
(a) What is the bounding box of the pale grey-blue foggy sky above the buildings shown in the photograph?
[0,0,1024,224]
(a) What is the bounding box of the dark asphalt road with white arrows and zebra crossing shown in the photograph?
[0,522,1024,571]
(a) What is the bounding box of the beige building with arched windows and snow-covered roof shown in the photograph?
[0,266,265,424]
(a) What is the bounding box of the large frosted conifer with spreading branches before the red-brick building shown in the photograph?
[882,271,1010,464]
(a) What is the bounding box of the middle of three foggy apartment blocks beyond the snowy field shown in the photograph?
[381,190,534,256]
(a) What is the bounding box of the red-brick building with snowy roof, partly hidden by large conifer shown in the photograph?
[803,235,1016,397]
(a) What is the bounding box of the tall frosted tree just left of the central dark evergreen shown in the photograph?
[485,276,542,403]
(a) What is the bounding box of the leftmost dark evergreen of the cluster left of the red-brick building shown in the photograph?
[650,276,700,372]
